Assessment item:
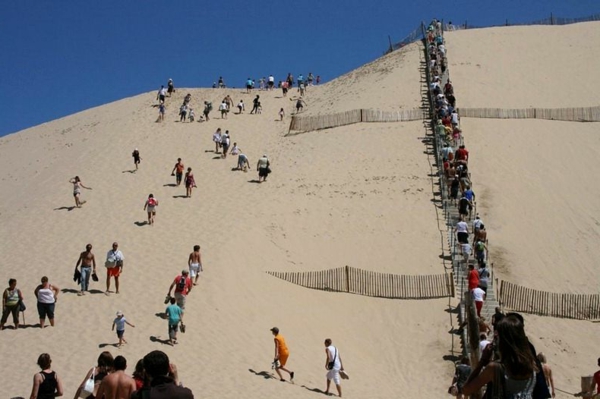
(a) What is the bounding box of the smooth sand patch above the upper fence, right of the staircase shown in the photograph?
[445,22,600,108]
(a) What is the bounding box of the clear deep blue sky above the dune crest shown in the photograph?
[0,0,600,136]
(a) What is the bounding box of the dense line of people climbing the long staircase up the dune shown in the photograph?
[426,20,600,399]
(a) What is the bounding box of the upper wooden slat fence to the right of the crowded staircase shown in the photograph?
[459,106,600,122]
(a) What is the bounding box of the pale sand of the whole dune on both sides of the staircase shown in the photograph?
[0,24,598,398]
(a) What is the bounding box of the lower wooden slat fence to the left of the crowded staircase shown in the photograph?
[267,266,454,299]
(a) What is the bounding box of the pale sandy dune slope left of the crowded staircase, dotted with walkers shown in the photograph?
[0,38,452,398]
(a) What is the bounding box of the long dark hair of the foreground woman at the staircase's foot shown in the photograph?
[496,313,536,377]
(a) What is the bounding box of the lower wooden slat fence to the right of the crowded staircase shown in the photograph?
[500,281,600,320]
